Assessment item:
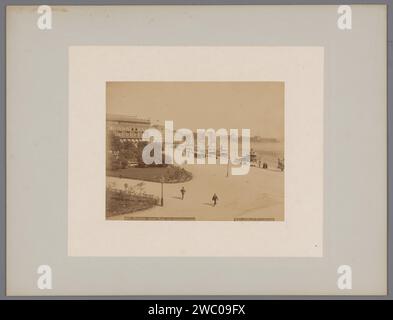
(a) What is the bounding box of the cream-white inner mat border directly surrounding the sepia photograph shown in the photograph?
[68,46,324,257]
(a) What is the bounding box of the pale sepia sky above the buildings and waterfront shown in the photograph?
[106,82,284,141]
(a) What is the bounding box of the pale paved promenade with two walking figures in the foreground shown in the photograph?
[107,165,284,220]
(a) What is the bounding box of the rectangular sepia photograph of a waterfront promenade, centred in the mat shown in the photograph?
[106,81,285,221]
